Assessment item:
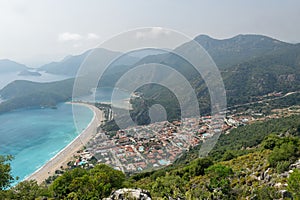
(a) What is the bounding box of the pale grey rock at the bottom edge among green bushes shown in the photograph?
[103,188,152,200]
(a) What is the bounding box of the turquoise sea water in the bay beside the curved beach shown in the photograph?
[0,104,93,184]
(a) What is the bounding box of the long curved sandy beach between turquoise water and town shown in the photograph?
[25,103,104,184]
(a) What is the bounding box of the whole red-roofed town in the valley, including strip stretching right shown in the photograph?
[74,106,300,173]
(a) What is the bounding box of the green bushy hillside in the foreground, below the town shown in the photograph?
[1,113,300,199]
